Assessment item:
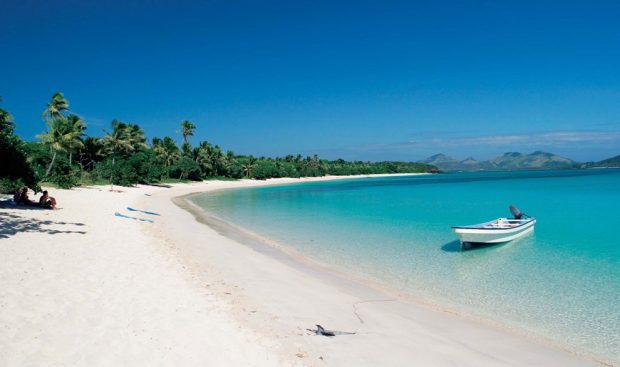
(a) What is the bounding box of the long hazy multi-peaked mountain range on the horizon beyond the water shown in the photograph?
[422,151,580,171]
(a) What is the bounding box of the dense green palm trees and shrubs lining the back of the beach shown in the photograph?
[0,92,437,193]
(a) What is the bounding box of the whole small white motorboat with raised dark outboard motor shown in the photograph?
[452,205,536,248]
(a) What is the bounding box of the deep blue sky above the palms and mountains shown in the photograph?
[0,0,620,161]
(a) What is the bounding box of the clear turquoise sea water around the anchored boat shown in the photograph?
[192,170,620,362]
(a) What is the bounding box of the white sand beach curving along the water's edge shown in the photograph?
[0,178,600,366]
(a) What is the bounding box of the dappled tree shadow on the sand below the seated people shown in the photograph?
[0,211,86,239]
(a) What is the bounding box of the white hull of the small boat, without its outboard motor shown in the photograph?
[453,219,536,245]
